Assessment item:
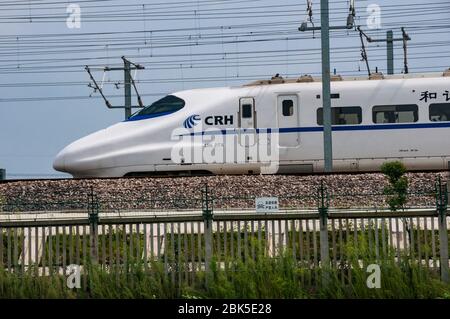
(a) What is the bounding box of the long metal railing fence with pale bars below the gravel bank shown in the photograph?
[0,180,449,282]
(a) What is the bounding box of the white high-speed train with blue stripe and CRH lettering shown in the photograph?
[53,69,450,177]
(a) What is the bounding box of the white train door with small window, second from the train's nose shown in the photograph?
[277,95,300,147]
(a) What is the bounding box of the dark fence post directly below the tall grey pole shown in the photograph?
[318,181,330,285]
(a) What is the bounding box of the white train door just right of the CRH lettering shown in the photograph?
[238,97,257,162]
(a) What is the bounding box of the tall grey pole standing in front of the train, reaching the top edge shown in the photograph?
[320,0,333,172]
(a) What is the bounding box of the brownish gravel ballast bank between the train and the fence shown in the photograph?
[0,172,448,210]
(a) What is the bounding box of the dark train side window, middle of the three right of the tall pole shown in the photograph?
[372,104,419,123]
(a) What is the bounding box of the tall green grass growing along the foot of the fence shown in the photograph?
[0,245,450,299]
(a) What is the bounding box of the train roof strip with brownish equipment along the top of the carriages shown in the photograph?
[243,68,450,87]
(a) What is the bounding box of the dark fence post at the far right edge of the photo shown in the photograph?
[436,176,449,283]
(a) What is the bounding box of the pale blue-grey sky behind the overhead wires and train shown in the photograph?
[0,0,450,178]
